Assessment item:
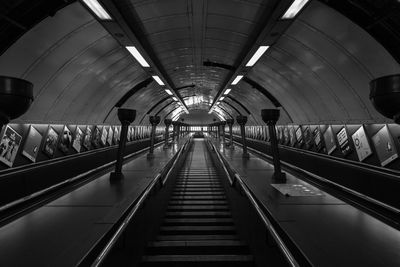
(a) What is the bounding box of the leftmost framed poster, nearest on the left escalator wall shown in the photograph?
[0,125,22,167]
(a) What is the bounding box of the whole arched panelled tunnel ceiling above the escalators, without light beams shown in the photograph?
[0,0,400,124]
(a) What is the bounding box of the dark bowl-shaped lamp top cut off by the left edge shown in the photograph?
[0,76,33,131]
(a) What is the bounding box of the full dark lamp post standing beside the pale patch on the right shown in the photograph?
[261,109,286,183]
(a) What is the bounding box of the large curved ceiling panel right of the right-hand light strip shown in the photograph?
[247,1,400,124]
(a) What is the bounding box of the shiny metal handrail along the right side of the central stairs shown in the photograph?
[212,138,300,267]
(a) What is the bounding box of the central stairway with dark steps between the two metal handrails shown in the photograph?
[142,139,254,267]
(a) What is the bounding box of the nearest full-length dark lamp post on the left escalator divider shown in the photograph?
[110,108,136,180]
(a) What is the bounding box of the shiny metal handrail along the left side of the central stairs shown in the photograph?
[91,139,190,267]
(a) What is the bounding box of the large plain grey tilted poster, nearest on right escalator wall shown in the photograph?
[372,125,398,166]
